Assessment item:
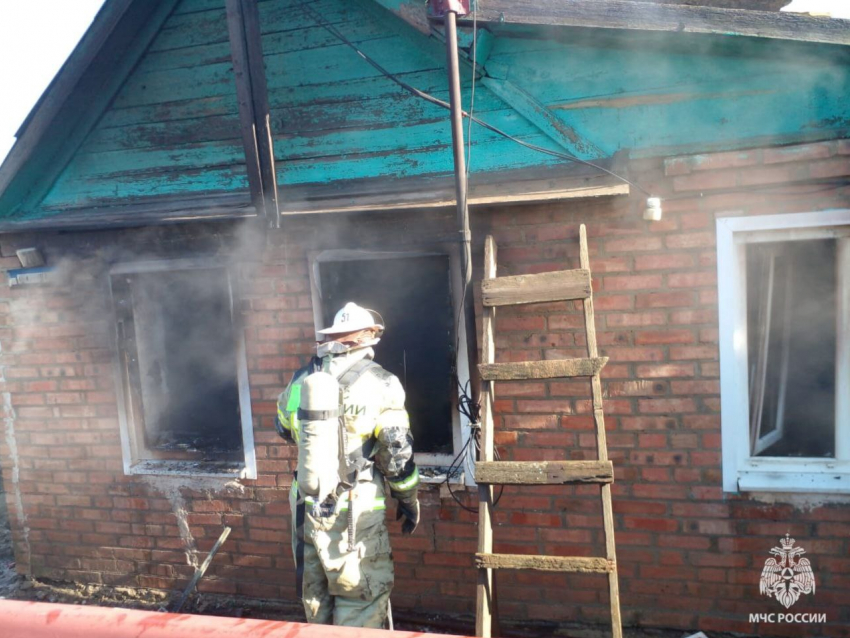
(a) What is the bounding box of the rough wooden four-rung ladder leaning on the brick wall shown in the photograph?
[475,224,623,638]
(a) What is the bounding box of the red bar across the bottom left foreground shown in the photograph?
[0,600,464,638]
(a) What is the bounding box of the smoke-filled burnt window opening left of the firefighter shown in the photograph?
[111,268,245,470]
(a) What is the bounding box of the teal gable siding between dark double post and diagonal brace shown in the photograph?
[260,0,551,185]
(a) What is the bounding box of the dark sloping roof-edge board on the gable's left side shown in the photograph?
[0,0,177,215]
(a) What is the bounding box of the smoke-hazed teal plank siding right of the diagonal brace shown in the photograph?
[486,32,850,161]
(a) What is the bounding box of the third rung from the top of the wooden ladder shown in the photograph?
[475,461,614,485]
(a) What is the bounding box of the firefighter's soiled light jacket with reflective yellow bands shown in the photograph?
[277,348,419,512]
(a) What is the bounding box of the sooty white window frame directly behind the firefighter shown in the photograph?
[307,246,475,485]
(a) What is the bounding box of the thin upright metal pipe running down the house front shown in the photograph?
[445,10,481,404]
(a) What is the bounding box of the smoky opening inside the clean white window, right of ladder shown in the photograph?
[746,239,838,458]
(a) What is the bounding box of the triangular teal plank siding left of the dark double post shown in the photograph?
[43,0,248,210]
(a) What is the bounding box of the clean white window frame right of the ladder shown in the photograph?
[716,209,850,494]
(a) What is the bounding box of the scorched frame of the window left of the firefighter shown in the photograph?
[108,258,257,479]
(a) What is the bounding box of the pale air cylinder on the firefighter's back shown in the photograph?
[298,372,339,501]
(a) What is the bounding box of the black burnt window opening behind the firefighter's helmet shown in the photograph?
[319,255,455,454]
